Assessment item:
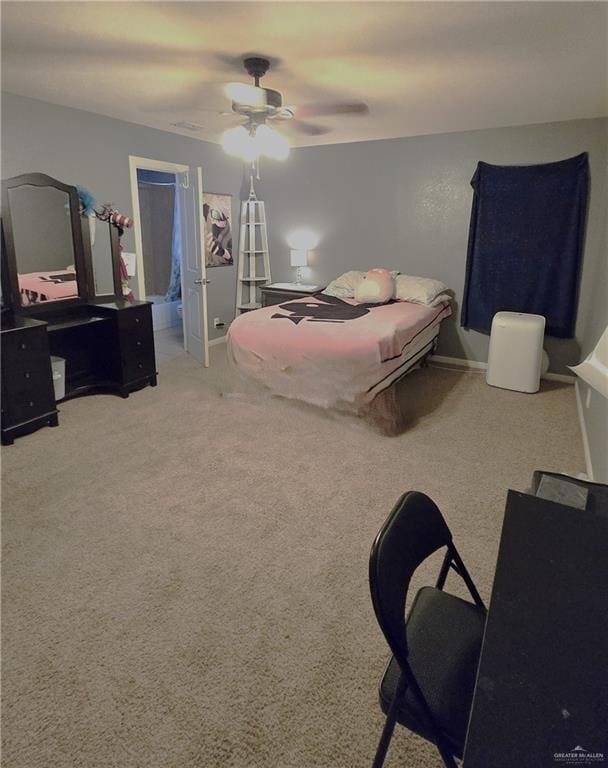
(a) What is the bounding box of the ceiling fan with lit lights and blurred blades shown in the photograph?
[222,56,369,162]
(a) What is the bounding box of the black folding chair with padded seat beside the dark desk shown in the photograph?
[369,491,486,768]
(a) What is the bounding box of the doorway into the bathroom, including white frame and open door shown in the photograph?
[129,156,209,366]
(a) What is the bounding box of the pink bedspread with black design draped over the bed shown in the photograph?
[227,295,451,411]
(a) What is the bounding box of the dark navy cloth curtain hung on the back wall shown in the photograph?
[461,152,589,338]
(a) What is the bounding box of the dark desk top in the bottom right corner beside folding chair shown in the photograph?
[464,491,608,768]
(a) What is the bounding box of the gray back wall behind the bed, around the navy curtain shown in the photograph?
[260,119,608,373]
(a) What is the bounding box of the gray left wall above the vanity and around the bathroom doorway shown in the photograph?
[2,93,243,338]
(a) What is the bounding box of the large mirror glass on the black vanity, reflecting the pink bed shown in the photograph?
[8,184,78,306]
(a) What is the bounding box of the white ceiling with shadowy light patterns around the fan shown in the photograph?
[2,2,608,145]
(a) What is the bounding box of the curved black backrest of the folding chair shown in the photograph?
[369,491,452,661]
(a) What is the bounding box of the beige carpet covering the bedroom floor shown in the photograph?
[2,346,584,768]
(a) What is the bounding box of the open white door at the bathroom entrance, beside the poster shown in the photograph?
[177,168,209,367]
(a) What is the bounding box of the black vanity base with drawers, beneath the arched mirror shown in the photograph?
[1,300,157,444]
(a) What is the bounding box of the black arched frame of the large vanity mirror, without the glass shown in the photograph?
[2,173,92,315]
